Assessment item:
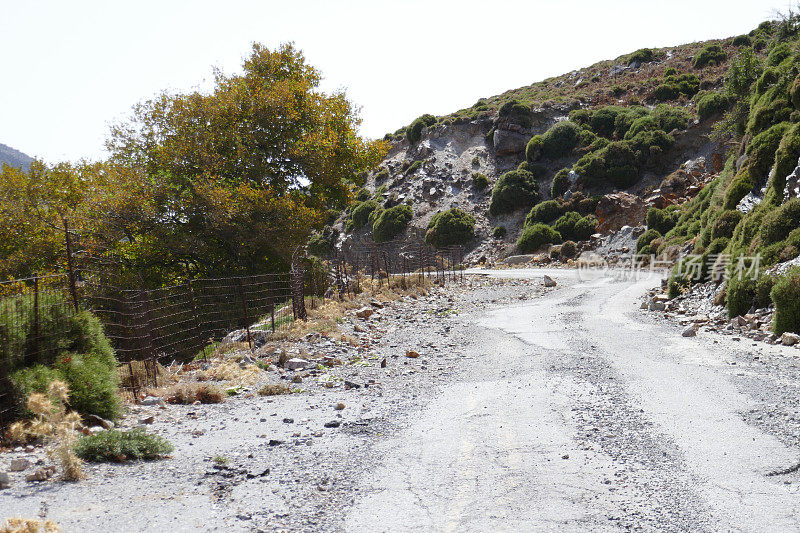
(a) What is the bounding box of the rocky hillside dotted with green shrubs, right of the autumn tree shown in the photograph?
[312,16,800,333]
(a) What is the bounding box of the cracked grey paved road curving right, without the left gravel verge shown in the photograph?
[344,270,800,532]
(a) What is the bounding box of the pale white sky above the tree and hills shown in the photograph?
[0,0,794,162]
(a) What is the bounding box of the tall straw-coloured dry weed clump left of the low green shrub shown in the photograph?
[9,380,84,481]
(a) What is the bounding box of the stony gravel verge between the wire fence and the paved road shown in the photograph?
[0,276,551,531]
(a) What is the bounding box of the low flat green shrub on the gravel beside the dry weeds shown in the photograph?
[75,429,173,463]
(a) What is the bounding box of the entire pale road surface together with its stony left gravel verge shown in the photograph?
[0,269,800,532]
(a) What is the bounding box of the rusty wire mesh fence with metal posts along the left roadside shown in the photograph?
[0,242,463,426]
